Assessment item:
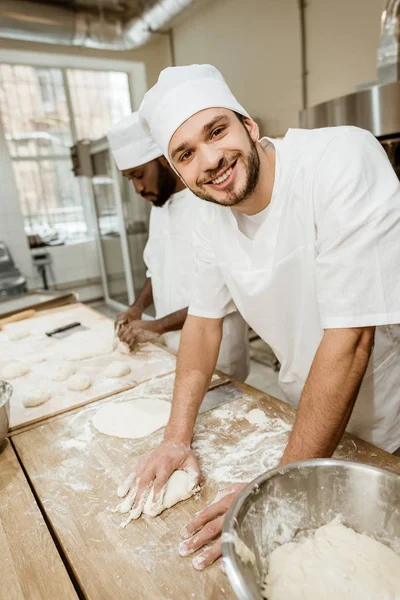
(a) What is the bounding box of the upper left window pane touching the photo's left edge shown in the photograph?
[0,64,72,157]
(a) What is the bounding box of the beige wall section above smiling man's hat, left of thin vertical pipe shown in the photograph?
[173,0,301,135]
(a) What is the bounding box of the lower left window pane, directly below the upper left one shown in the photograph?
[13,159,87,239]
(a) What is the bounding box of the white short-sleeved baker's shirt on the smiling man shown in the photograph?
[189,127,400,452]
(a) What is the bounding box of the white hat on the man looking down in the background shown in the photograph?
[107,112,162,171]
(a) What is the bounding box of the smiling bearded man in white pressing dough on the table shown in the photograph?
[126,65,400,569]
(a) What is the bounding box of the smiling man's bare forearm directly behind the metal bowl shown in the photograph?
[280,327,375,464]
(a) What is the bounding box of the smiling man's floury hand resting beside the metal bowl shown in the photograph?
[179,483,247,571]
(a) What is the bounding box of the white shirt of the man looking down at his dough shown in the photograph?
[143,189,249,381]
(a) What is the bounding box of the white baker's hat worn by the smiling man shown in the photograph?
[139,65,249,160]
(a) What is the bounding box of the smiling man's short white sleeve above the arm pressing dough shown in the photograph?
[189,217,237,319]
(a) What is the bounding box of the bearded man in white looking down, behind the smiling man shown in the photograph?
[108,112,249,381]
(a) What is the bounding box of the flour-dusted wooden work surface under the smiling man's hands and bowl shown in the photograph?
[13,384,400,600]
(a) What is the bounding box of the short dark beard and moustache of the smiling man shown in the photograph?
[192,129,260,206]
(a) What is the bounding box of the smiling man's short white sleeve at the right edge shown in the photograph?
[313,128,400,329]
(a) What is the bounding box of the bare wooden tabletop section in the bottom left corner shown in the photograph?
[0,442,78,600]
